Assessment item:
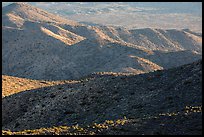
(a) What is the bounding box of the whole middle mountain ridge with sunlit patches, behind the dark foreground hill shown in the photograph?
[2,2,202,81]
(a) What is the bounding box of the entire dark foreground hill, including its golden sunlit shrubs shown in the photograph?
[2,60,202,135]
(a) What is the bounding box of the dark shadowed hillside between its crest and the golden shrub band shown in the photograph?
[2,62,202,131]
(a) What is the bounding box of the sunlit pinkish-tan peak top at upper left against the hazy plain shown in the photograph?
[2,2,79,27]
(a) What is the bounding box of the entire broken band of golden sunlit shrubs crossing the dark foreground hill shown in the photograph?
[2,106,202,135]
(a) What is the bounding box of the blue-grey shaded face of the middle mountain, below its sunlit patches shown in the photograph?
[2,22,161,80]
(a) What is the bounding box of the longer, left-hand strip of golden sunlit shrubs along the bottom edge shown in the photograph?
[2,117,127,135]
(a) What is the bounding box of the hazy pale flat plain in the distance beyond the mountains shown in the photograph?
[3,2,202,33]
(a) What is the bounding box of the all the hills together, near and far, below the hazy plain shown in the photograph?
[2,2,202,135]
